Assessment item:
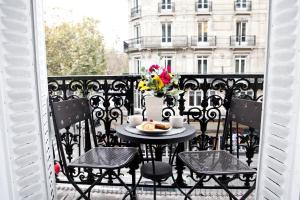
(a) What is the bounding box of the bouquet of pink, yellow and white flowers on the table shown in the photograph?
[138,65,183,97]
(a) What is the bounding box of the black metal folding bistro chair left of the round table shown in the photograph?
[50,98,138,200]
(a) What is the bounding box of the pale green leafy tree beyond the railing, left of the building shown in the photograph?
[46,18,107,75]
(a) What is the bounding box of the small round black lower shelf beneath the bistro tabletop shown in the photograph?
[141,161,172,181]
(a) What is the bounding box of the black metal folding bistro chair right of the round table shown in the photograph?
[178,98,262,200]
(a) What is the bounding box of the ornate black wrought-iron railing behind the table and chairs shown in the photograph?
[48,74,264,188]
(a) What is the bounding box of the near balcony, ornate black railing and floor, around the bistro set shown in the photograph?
[48,74,263,199]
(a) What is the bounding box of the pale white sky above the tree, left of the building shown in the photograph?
[44,0,128,51]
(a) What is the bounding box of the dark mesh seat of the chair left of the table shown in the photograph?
[68,147,138,169]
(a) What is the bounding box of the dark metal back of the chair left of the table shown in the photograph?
[50,98,98,175]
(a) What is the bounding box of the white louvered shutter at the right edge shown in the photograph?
[256,0,300,200]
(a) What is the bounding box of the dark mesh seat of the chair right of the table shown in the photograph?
[178,151,256,175]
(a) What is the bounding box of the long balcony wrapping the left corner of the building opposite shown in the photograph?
[124,36,188,52]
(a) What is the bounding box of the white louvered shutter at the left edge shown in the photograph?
[0,0,55,200]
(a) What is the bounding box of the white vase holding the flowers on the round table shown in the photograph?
[145,96,164,121]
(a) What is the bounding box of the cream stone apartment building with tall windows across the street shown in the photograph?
[124,0,268,74]
